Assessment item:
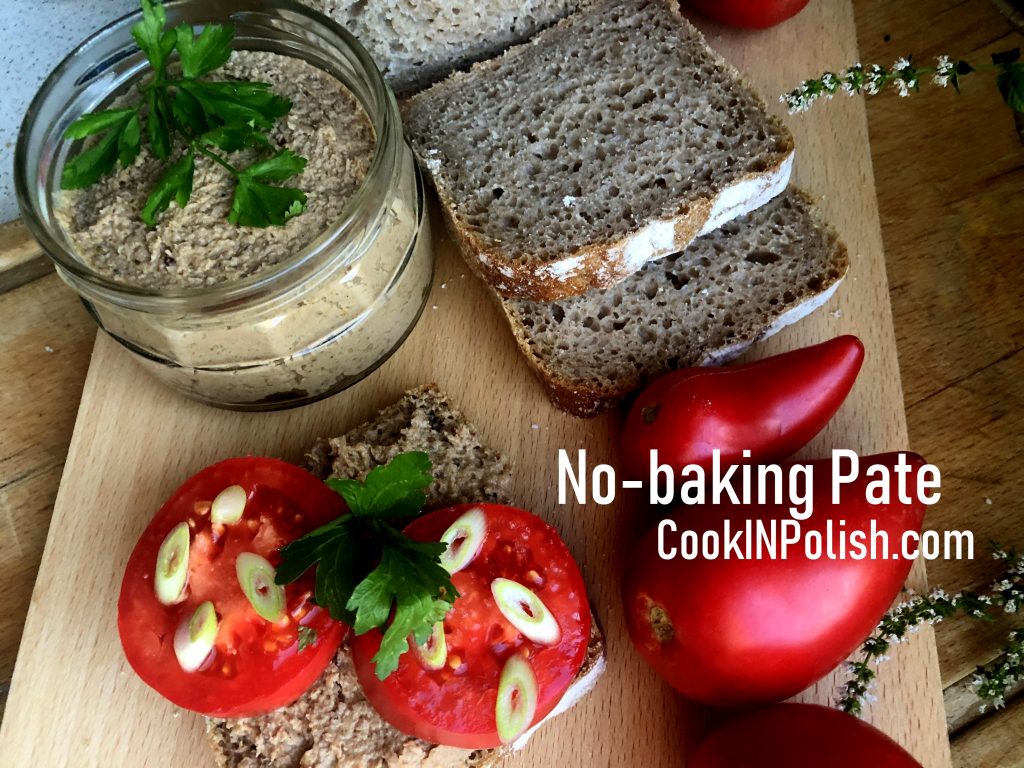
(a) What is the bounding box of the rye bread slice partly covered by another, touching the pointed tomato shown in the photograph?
[500,188,849,417]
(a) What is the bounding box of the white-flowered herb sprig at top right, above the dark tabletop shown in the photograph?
[779,48,1024,115]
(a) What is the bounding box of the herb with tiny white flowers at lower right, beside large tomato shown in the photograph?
[837,548,1024,715]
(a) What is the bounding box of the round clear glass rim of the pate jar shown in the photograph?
[14,0,404,311]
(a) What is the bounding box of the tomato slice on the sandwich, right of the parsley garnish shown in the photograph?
[352,504,591,750]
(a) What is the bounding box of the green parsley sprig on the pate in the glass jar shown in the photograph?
[60,0,306,227]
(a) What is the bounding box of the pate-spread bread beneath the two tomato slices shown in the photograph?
[206,386,604,768]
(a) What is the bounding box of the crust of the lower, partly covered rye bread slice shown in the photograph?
[494,188,850,419]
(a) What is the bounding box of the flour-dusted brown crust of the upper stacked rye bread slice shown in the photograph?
[403,0,795,301]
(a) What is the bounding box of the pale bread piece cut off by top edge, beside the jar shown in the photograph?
[302,0,580,96]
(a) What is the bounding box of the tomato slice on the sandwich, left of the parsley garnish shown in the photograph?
[118,458,346,717]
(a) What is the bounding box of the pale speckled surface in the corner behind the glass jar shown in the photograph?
[0,0,138,221]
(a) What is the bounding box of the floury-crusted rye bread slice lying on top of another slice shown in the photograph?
[404,0,794,300]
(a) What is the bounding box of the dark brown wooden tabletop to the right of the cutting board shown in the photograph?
[856,0,1024,768]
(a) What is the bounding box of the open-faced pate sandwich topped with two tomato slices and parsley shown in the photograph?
[118,387,604,768]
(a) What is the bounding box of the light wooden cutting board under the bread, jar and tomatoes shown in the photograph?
[0,0,949,768]
